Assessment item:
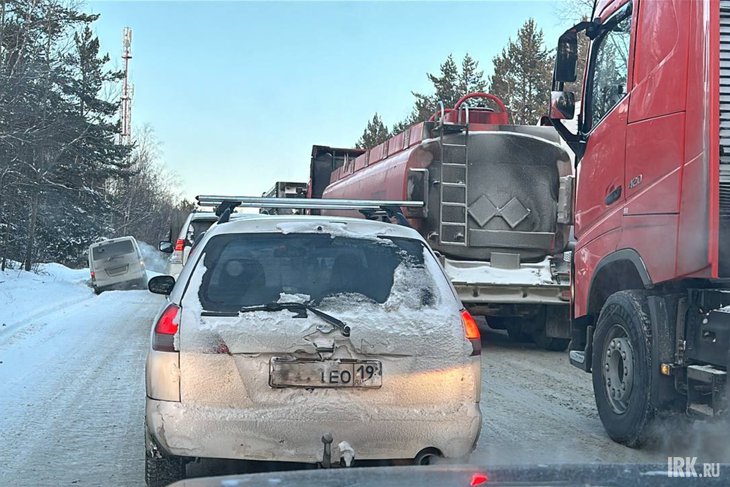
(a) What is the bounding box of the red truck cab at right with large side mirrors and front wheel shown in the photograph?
[550,0,730,447]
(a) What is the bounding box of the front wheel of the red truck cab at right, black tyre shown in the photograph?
[593,291,654,448]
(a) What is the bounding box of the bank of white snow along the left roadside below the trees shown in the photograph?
[0,263,94,333]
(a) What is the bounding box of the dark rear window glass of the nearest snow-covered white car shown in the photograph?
[193,233,434,311]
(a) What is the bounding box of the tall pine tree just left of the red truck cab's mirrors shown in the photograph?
[490,19,553,125]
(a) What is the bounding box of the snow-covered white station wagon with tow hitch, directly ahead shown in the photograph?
[146,216,481,485]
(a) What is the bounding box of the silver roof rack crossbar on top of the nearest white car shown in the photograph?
[195,195,424,226]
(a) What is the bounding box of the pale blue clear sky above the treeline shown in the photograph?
[87,0,570,198]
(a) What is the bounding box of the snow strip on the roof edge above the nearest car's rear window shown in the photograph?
[203,215,423,240]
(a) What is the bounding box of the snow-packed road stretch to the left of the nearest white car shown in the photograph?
[0,291,164,486]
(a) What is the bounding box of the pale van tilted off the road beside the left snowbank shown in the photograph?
[89,237,147,294]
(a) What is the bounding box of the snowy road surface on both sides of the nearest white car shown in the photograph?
[0,291,730,486]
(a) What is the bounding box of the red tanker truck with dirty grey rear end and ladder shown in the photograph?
[309,93,573,351]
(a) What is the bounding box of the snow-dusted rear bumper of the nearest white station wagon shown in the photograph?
[146,398,482,463]
